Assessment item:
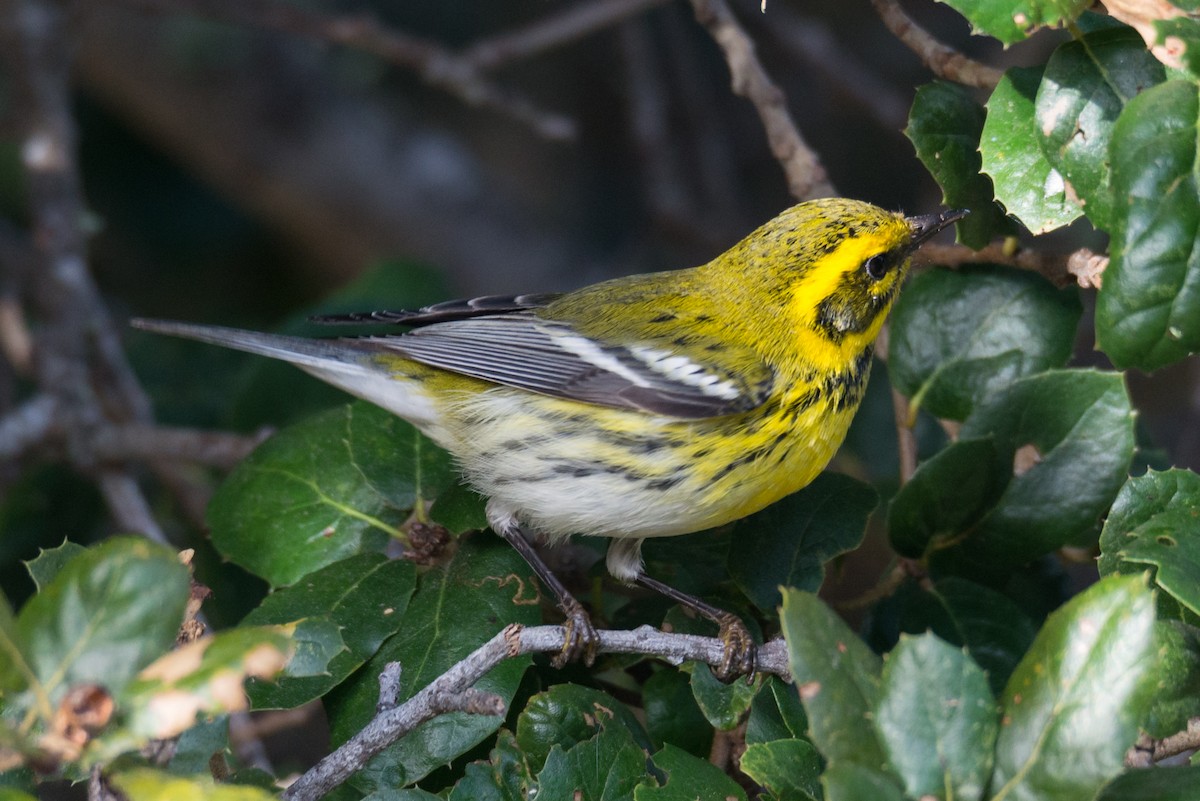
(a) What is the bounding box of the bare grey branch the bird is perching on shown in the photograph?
[282,625,790,801]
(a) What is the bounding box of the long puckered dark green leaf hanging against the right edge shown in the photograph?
[1096,80,1200,371]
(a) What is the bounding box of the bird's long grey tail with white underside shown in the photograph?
[130,318,438,429]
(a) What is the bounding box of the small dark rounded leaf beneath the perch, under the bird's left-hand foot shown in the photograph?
[516,685,650,767]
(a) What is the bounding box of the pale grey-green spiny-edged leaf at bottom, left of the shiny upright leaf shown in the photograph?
[875,633,1000,800]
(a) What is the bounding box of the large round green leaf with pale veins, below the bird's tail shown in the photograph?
[208,402,452,586]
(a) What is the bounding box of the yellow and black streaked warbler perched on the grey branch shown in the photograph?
[133,199,966,675]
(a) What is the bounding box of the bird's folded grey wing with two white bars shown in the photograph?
[360,312,774,420]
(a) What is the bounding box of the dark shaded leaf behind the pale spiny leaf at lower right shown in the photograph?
[899,576,1037,693]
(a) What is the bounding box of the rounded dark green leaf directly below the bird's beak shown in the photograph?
[888,265,1081,420]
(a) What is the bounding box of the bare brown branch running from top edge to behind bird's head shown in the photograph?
[691,0,836,200]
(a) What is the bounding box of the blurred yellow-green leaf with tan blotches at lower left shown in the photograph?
[124,626,294,740]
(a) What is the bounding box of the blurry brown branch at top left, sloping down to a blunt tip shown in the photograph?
[111,0,575,140]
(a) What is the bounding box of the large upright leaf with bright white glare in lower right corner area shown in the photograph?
[991,576,1154,801]
